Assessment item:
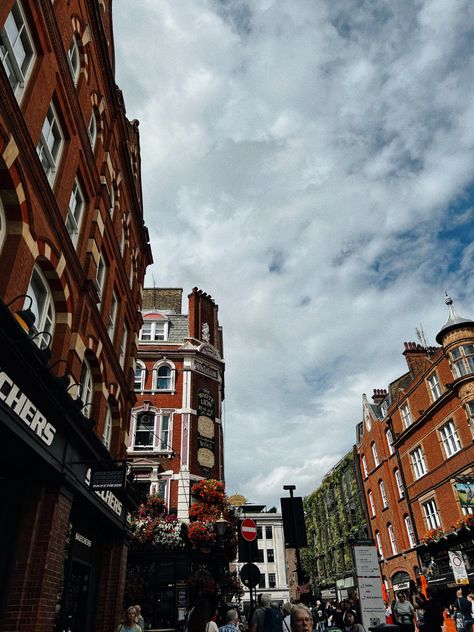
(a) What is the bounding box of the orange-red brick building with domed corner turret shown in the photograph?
[358,299,474,596]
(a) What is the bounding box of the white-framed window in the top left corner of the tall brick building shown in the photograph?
[0,0,36,101]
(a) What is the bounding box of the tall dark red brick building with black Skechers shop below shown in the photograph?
[0,0,151,632]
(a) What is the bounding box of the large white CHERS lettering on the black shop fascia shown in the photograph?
[0,370,56,445]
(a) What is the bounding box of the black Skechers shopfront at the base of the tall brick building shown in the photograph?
[0,302,133,632]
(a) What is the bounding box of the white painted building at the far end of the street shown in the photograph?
[237,505,289,606]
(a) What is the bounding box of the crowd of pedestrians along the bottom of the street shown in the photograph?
[116,587,474,632]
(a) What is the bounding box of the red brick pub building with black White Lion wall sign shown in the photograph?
[128,288,224,520]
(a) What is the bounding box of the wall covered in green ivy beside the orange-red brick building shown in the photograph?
[301,450,368,592]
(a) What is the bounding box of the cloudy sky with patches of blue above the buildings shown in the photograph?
[114,0,474,505]
